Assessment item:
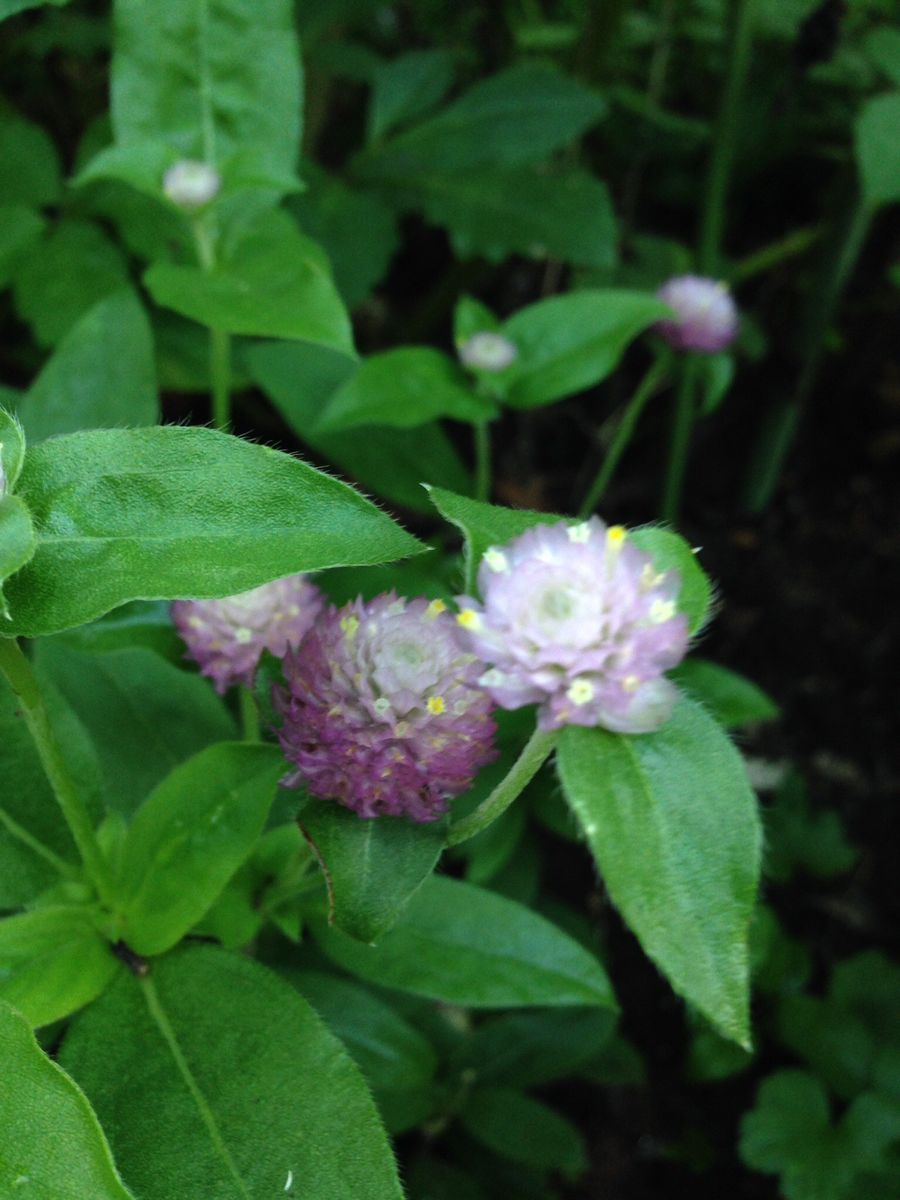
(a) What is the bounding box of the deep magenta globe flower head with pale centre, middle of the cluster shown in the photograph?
[275,592,494,821]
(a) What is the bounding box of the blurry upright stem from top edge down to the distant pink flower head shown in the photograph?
[697,0,756,275]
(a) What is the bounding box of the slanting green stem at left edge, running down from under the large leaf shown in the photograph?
[0,637,114,904]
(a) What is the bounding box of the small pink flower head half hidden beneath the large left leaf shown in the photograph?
[172,575,325,695]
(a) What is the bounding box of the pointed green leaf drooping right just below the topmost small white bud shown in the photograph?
[144,212,354,355]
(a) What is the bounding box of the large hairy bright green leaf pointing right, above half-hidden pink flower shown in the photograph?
[4,426,421,637]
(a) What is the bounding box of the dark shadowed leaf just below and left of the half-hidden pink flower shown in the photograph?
[36,638,236,816]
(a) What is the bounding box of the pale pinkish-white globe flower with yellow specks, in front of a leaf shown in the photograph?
[457,517,688,733]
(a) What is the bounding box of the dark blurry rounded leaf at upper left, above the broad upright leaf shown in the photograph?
[13,218,128,346]
